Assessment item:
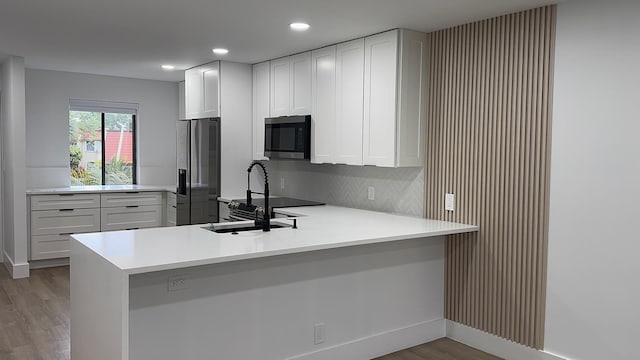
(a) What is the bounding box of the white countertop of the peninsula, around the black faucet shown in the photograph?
[72,205,478,274]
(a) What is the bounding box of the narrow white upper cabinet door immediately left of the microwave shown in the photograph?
[253,61,270,160]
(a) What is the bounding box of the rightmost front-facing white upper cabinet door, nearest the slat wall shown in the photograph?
[363,30,398,167]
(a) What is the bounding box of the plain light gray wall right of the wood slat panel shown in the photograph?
[545,0,640,360]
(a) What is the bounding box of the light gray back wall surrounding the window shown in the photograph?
[26,69,178,187]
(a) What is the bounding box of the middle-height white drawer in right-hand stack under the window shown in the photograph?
[100,205,162,231]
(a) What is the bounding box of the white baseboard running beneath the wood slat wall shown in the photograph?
[446,320,568,360]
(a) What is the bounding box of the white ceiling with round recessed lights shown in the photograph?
[0,0,557,81]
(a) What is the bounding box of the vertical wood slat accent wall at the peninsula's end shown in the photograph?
[425,6,556,349]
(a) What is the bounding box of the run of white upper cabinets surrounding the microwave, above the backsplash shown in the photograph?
[253,29,429,167]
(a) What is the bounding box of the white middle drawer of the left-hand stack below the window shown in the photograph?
[31,209,100,236]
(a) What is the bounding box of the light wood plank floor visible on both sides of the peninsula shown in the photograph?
[0,264,499,360]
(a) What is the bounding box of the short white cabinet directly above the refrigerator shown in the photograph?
[184,61,220,119]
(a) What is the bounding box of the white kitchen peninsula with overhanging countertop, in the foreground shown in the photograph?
[71,206,478,360]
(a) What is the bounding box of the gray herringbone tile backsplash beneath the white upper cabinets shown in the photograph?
[265,160,424,217]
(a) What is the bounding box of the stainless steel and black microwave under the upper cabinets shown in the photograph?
[264,115,311,160]
